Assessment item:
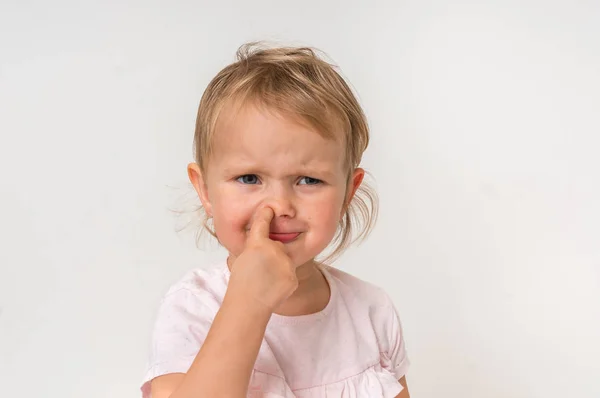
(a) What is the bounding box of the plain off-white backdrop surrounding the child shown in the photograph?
[0,0,600,398]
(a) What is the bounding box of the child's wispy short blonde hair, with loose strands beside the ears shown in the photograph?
[194,43,378,260]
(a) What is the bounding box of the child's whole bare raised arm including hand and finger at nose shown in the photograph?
[151,207,298,398]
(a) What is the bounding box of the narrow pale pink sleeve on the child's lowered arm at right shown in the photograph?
[380,294,410,379]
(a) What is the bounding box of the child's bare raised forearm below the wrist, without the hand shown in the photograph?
[151,295,271,398]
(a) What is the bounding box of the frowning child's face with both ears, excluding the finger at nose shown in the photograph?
[188,102,364,266]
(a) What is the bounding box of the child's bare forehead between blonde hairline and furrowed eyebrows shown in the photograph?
[211,105,345,171]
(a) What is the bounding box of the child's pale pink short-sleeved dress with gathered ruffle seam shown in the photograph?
[141,262,409,398]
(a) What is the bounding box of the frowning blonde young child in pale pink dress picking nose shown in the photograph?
[142,45,409,398]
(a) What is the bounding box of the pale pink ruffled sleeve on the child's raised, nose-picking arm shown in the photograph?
[141,289,214,398]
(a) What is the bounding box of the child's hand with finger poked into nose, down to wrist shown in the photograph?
[227,207,298,314]
